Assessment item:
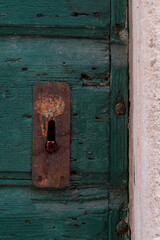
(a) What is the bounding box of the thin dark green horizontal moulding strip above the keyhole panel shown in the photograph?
[0,25,109,39]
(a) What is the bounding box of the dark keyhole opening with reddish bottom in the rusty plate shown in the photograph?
[45,120,58,153]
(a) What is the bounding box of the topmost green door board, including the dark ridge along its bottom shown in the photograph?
[0,0,110,38]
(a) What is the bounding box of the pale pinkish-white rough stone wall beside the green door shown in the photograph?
[130,0,160,240]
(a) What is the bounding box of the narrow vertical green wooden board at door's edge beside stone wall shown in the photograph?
[108,0,130,240]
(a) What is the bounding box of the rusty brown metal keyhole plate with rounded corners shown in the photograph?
[32,82,70,188]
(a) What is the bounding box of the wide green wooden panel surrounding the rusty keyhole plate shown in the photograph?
[0,38,110,183]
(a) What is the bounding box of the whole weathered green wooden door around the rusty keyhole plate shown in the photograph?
[0,0,128,240]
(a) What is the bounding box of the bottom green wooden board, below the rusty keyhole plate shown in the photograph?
[0,187,108,240]
